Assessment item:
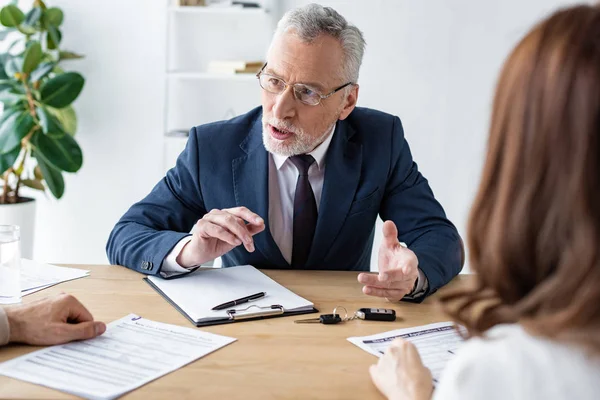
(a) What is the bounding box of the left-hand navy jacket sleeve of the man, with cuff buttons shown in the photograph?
[106,128,206,275]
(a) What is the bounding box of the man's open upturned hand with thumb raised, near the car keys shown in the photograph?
[358,221,419,301]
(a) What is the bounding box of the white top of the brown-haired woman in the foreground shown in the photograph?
[433,325,600,400]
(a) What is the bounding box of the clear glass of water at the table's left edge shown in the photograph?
[0,225,21,302]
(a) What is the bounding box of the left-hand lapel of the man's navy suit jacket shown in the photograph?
[231,115,290,268]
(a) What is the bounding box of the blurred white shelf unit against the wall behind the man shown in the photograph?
[163,0,279,172]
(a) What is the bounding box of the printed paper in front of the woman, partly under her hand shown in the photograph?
[348,322,463,382]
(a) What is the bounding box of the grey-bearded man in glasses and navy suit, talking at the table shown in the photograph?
[107,4,463,301]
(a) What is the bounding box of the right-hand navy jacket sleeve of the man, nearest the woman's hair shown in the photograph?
[380,117,463,301]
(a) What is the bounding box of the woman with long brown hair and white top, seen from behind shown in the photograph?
[371,5,600,400]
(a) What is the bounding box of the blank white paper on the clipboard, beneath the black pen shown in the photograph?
[148,265,314,322]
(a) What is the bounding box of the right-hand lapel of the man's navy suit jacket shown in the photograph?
[307,121,362,268]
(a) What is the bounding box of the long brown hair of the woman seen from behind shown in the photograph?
[441,5,600,351]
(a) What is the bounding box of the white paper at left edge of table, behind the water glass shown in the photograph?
[0,258,90,304]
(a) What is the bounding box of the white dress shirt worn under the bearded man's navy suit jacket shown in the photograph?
[161,125,427,296]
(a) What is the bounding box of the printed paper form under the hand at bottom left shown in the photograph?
[0,314,236,399]
